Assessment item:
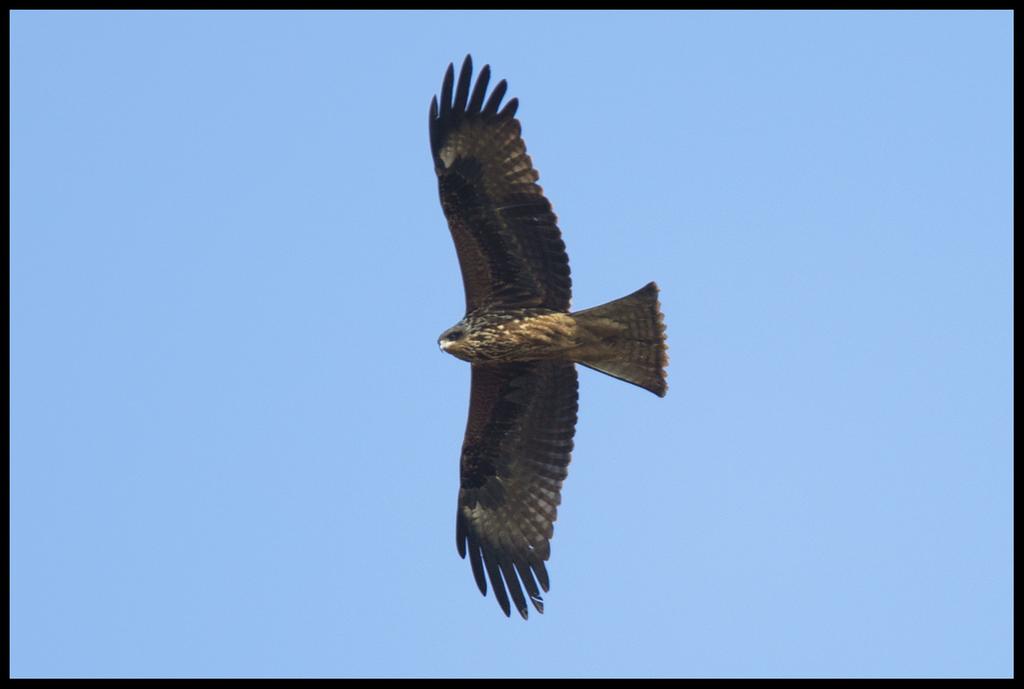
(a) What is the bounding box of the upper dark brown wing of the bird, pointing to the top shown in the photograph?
[430,55,571,313]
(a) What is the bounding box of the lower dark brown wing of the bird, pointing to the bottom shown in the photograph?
[456,361,578,619]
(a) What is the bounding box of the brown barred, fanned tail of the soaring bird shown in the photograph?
[572,283,669,397]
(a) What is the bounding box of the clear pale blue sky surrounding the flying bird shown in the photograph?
[10,12,1013,677]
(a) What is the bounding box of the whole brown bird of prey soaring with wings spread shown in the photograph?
[430,55,668,619]
